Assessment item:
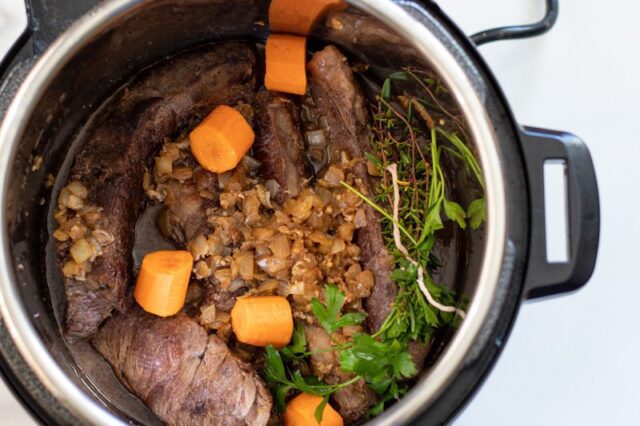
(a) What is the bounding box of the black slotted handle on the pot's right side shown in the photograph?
[520,127,600,299]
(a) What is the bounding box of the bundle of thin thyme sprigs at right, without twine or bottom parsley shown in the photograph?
[345,69,485,350]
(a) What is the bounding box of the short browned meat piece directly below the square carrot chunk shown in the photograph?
[253,92,306,203]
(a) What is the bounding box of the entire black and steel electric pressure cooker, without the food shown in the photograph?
[0,0,599,425]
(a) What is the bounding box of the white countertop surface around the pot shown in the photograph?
[0,0,640,426]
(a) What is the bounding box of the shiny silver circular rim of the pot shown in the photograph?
[0,0,507,425]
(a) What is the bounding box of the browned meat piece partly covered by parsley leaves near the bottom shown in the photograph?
[304,325,376,421]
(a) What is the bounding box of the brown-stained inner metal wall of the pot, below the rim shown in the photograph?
[2,0,491,424]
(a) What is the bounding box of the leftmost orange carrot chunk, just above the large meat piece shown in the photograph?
[133,250,193,317]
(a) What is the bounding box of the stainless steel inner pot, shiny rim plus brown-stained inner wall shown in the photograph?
[0,0,597,425]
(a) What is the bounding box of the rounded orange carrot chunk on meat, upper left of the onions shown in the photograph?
[189,105,256,173]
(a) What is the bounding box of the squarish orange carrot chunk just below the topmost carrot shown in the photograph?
[264,34,307,95]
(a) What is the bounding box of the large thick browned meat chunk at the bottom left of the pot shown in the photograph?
[93,307,271,426]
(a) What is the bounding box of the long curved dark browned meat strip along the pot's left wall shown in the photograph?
[58,44,255,337]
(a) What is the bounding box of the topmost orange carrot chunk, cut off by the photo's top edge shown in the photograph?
[269,0,346,35]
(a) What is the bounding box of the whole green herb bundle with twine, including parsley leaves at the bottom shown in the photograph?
[266,69,485,420]
